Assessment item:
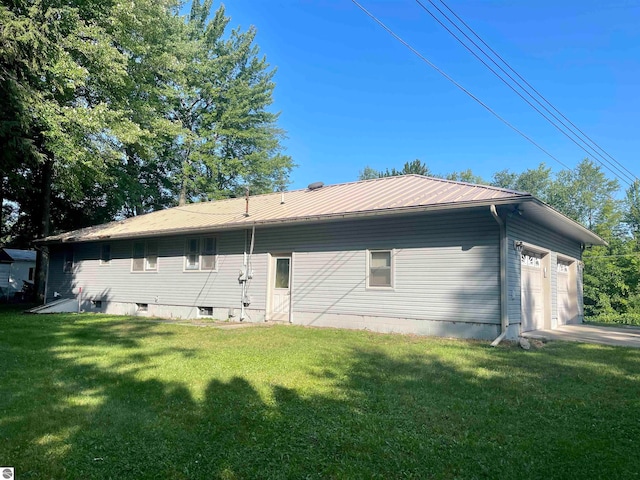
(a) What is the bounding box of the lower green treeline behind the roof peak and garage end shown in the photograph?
[360,159,640,324]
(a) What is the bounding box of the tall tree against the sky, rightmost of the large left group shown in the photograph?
[170,0,293,204]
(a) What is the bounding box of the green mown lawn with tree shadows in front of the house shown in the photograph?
[0,308,640,479]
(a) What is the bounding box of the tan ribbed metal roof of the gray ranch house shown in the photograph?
[44,175,604,246]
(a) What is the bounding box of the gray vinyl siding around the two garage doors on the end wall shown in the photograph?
[507,217,582,325]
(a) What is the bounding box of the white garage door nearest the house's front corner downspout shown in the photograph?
[520,252,544,332]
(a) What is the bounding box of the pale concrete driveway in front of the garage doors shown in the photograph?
[522,324,640,348]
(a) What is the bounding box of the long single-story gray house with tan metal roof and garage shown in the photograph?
[38,175,604,339]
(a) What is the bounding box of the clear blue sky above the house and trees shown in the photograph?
[216,0,640,189]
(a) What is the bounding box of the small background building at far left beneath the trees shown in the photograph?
[0,248,36,301]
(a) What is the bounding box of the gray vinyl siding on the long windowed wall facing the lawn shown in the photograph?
[48,209,500,324]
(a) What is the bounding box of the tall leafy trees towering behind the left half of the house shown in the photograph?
[0,0,293,247]
